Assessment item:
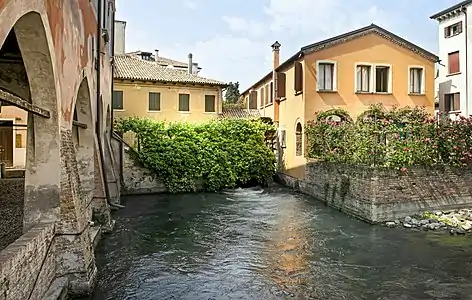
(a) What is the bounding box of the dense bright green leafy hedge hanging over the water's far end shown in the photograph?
[115,117,275,192]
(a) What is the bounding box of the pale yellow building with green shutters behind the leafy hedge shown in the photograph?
[113,54,226,123]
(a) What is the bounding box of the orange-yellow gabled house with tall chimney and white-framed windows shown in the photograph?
[241,24,438,178]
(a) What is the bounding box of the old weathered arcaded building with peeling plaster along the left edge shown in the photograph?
[0,0,119,300]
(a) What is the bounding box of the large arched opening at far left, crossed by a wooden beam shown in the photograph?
[0,12,61,247]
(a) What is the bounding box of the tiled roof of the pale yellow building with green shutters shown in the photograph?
[114,54,227,87]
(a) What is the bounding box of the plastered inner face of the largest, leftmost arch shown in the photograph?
[2,12,61,230]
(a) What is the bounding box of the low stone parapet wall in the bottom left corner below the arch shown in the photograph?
[0,223,56,300]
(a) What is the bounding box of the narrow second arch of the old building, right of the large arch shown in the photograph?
[72,78,95,220]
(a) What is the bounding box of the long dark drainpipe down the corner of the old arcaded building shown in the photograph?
[95,1,121,208]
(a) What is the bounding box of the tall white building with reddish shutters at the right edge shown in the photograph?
[430,0,472,116]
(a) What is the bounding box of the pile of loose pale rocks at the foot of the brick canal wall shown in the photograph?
[384,209,472,235]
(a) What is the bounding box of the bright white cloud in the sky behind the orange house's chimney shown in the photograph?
[165,0,394,89]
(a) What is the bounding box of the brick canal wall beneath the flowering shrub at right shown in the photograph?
[278,162,472,223]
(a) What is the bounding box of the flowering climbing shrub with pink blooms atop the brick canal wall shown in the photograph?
[306,105,472,171]
